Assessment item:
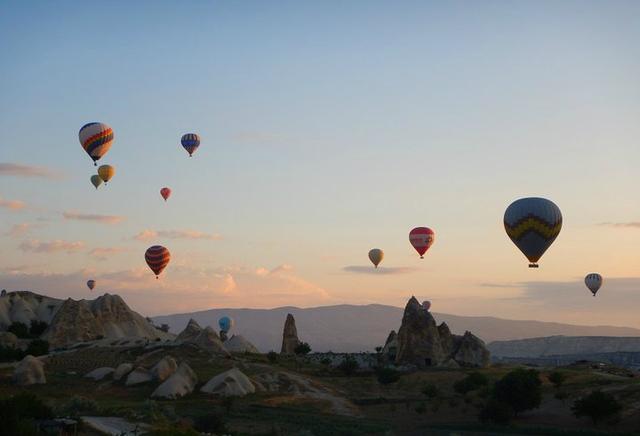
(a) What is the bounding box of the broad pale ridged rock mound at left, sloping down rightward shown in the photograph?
[43,294,171,347]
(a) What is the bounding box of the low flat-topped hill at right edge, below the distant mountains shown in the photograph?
[489,336,640,357]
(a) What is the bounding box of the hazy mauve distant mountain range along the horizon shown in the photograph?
[153,304,640,352]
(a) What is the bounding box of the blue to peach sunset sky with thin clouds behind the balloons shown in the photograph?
[0,1,640,327]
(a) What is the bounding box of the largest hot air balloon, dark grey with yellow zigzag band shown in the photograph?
[504,197,562,268]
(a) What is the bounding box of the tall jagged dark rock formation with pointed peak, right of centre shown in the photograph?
[396,297,489,368]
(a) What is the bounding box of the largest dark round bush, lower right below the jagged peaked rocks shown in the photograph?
[493,368,542,415]
